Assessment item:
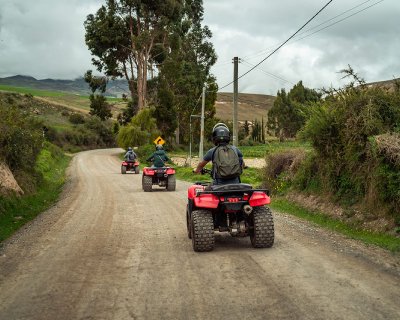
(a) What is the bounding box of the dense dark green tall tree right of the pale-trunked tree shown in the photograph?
[155,0,218,143]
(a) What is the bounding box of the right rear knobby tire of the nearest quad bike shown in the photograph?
[250,207,275,248]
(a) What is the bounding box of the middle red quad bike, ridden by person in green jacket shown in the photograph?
[142,167,176,192]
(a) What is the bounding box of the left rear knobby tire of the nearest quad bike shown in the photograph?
[191,210,215,251]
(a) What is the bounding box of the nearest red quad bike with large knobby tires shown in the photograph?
[186,169,275,251]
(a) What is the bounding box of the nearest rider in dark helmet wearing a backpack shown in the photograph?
[193,123,244,184]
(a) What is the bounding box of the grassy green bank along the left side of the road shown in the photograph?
[0,144,71,242]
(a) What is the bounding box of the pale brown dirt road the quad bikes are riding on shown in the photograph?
[0,149,400,319]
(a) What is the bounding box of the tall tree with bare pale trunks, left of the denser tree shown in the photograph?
[84,0,184,114]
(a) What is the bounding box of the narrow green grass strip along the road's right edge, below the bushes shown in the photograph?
[270,198,400,252]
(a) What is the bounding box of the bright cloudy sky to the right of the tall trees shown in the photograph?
[205,0,400,94]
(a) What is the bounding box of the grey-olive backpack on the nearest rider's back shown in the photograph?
[212,145,242,179]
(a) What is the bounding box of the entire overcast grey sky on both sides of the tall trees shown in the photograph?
[0,0,400,95]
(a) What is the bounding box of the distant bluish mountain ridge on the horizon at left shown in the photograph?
[0,75,129,97]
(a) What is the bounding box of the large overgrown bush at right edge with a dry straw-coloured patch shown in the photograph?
[296,70,400,220]
